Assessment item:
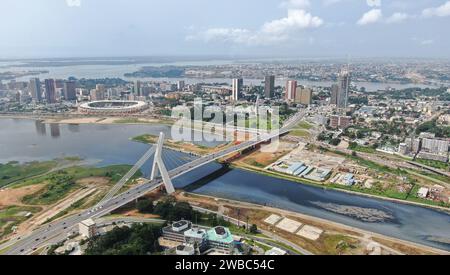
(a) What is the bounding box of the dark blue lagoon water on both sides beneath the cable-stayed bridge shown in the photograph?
[0,119,450,251]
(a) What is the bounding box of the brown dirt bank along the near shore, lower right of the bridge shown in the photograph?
[176,193,445,255]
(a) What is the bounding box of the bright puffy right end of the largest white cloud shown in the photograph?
[262,10,323,34]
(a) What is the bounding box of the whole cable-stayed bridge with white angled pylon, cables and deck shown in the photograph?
[6,111,306,255]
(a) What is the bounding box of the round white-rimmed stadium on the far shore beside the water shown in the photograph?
[78,100,148,115]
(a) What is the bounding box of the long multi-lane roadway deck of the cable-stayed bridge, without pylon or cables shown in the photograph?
[5,112,305,255]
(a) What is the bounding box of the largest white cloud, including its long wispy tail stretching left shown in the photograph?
[186,9,324,45]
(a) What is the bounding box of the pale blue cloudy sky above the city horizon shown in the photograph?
[0,0,450,58]
